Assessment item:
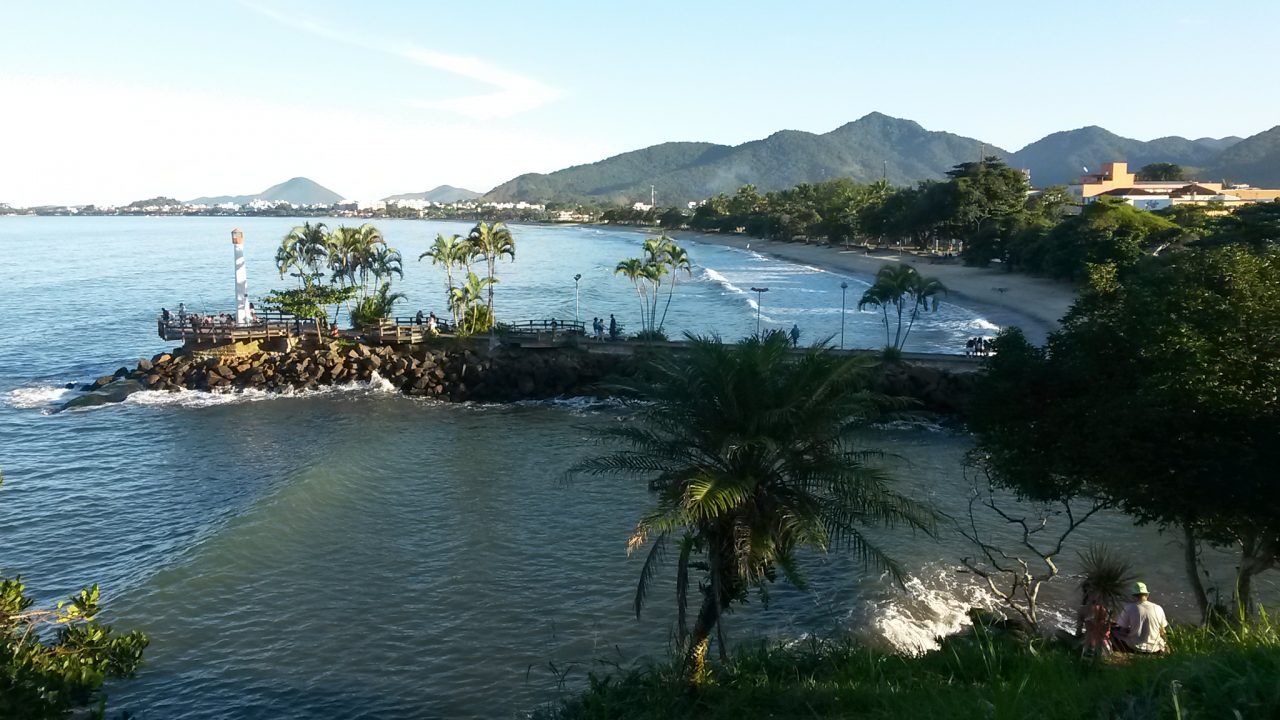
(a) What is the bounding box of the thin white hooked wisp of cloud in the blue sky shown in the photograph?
[241,0,561,120]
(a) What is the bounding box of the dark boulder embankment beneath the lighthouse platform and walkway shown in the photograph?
[63,342,973,415]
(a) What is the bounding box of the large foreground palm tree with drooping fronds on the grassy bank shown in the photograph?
[570,334,933,682]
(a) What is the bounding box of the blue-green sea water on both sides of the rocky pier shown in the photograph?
[0,218,1264,719]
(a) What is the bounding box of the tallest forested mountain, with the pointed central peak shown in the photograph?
[485,113,1007,205]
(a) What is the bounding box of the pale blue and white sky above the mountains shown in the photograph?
[0,0,1280,206]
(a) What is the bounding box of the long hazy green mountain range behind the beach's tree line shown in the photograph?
[484,113,1280,205]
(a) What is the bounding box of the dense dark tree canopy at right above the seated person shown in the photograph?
[973,243,1280,614]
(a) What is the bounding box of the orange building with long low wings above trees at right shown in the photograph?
[1068,163,1280,210]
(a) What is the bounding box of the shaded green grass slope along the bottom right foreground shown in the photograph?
[535,615,1280,720]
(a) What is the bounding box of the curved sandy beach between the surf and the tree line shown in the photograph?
[673,232,1075,343]
